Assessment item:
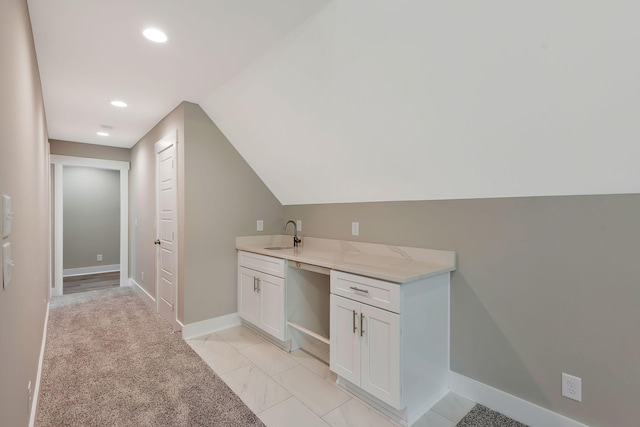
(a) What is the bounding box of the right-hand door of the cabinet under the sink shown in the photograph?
[257,273,285,341]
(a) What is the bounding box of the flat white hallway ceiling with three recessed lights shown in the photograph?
[28,0,329,148]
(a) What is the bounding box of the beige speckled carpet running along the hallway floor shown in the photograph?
[36,288,263,427]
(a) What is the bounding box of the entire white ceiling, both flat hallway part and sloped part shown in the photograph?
[28,0,640,205]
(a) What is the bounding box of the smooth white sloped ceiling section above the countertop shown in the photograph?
[201,0,640,205]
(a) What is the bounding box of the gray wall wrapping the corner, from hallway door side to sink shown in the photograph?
[130,102,283,324]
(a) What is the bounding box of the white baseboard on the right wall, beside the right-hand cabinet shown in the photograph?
[449,371,588,427]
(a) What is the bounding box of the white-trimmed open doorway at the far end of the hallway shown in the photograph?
[51,155,129,296]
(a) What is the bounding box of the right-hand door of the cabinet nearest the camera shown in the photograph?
[358,304,402,409]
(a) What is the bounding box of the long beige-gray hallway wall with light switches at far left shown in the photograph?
[0,0,49,426]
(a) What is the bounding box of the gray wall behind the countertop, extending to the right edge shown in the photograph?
[285,194,640,427]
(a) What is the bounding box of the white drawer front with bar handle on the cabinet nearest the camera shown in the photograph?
[331,270,400,313]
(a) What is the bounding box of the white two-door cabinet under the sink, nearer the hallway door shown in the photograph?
[238,251,286,341]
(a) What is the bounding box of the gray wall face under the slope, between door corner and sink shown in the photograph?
[183,103,283,323]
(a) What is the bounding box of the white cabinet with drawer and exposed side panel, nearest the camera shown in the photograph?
[330,270,449,425]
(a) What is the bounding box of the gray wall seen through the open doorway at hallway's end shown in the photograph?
[62,166,120,269]
